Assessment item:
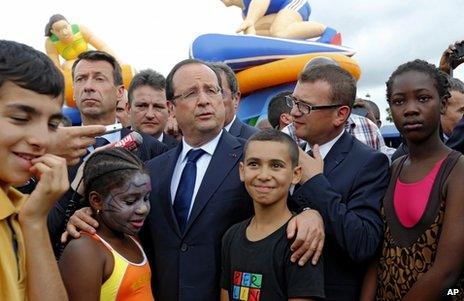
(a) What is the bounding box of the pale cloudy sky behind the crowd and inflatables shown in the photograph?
[0,0,464,123]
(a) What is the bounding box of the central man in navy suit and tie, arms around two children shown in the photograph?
[138,60,323,300]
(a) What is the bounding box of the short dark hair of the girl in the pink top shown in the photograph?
[386,59,451,101]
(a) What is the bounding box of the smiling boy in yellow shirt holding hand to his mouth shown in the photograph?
[0,40,69,301]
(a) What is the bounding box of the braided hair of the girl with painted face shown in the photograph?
[83,147,146,202]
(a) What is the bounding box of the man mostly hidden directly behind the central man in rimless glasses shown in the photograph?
[211,63,259,140]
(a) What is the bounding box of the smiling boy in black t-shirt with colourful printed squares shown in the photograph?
[221,129,324,301]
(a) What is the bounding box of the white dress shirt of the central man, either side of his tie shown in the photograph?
[171,131,222,216]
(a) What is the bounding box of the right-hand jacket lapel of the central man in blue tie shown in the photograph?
[185,131,242,233]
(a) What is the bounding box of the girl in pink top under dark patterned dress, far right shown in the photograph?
[361,60,464,300]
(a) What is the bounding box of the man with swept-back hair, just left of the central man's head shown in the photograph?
[126,69,179,149]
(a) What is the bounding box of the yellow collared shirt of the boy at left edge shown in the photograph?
[0,188,27,301]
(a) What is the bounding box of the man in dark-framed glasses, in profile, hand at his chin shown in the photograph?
[286,65,389,300]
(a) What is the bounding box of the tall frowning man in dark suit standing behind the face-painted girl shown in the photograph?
[48,51,167,255]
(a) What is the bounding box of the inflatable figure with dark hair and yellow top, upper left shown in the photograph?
[45,14,116,70]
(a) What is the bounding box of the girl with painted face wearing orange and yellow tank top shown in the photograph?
[59,148,154,300]
